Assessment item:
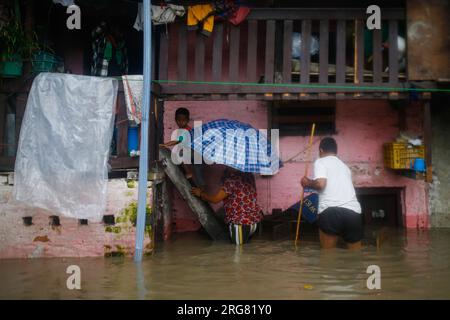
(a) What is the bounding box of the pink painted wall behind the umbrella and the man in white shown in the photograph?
[164,100,429,232]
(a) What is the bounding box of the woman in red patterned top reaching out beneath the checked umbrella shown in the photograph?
[191,168,263,245]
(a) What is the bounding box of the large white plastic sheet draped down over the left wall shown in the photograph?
[13,73,118,221]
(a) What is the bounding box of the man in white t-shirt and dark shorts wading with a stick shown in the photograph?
[301,138,363,249]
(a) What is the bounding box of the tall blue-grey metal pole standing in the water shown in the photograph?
[134,0,152,262]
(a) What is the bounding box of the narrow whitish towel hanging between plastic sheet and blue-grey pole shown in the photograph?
[122,75,144,125]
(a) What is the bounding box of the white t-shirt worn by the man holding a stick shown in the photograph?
[314,156,361,213]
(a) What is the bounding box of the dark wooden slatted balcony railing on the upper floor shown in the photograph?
[158,8,406,99]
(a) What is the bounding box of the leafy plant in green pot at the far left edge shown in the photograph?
[0,19,39,78]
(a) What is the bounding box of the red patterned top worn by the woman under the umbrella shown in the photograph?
[223,175,262,225]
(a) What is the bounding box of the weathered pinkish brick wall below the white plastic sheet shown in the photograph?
[0,179,152,259]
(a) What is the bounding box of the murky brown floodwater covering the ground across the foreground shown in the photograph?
[0,230,450,299]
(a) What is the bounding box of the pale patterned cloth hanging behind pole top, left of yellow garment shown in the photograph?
[133,3,186,31]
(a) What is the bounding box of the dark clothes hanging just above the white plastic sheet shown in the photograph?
[91,22,128,77]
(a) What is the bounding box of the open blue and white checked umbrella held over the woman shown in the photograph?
[182,119,281,175]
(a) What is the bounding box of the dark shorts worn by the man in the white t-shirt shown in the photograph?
[318,207,363,243]
